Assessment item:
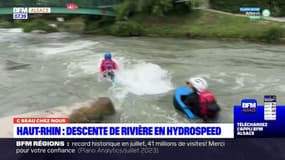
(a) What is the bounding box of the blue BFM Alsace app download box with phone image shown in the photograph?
[234,97,285,138]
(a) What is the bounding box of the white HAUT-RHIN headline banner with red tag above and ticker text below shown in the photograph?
[13,118,231,154]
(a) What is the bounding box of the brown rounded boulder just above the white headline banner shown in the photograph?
[69,97,115,123]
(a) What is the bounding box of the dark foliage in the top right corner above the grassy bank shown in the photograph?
[210,0,285,16]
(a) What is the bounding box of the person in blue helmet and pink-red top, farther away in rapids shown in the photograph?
[100,52,119,77]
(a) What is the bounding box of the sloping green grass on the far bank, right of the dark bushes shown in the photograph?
[126,10,285,40]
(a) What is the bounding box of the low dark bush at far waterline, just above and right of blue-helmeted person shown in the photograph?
[111,21,142,36]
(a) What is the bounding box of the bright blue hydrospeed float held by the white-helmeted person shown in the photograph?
[173,87,195,119]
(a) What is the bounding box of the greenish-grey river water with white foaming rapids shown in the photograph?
[0,29,285,123]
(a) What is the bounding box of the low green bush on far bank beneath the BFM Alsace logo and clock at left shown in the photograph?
[23,20,58,33]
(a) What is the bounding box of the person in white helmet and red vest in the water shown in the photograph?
[184,77,221,122]
